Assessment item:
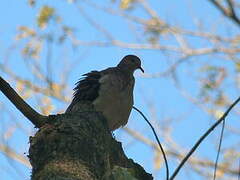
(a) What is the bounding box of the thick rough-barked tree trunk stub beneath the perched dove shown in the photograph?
[29,103,153,180]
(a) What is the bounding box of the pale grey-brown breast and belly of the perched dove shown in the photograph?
[93,73,134,131]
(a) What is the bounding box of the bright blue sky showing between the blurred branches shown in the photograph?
[0,0,239,180]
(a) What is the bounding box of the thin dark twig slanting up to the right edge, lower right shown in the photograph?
[170,97,240,180]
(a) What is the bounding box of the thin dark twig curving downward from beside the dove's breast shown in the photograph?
[133,106,169,180]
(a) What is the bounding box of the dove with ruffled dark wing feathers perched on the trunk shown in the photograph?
[65,55,144,131]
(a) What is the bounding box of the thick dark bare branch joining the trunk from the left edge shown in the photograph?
[0,76,47,128]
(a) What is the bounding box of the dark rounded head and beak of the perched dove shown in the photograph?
[118,55,144,73]
